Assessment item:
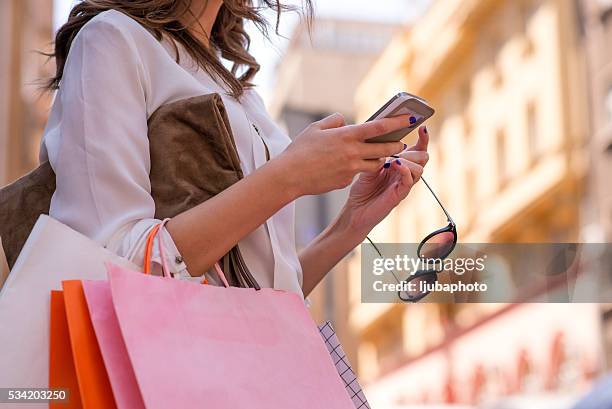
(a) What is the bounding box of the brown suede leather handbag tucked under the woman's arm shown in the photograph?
[0,93,259,288]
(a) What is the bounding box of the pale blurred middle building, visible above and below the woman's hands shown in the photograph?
[269,18,399,361]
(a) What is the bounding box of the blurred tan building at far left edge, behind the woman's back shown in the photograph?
[0,0,53,281]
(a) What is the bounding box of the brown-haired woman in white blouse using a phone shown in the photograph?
[40,0,428,295]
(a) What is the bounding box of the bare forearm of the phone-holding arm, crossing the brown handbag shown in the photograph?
[167,157,298,276]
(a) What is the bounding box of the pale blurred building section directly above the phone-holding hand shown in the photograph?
[269,18,399,136]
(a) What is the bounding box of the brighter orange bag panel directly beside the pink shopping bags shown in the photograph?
[62,280,116,409]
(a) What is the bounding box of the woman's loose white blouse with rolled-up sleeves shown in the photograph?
[40,10,302,295]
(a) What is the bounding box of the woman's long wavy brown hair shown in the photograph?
[45,0,313,98]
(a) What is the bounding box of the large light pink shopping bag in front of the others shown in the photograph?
[108,258,354,409]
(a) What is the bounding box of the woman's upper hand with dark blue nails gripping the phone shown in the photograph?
[277,114,410,197]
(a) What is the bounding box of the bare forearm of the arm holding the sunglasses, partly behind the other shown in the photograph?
[299,211,367,296]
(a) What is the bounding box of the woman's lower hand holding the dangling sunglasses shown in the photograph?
[344,126,429,235]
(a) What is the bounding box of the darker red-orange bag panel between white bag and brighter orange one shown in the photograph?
[49,291,83,409]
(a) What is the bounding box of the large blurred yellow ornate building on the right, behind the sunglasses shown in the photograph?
[344,0,609,408]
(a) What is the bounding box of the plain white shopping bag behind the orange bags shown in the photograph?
[0,215,139,388]
